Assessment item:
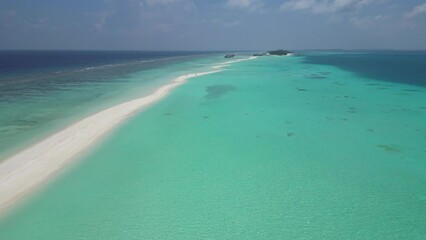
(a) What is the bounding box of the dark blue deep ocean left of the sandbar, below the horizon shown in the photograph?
[0,51,218,99]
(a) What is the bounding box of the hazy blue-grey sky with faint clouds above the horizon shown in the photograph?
[0,0,426,50]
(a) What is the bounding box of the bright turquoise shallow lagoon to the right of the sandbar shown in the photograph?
[0,57,426,239]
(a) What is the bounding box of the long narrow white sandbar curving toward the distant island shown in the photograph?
[0,57,254,213]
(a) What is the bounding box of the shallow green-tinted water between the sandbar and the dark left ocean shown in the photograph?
[0,52,223,161]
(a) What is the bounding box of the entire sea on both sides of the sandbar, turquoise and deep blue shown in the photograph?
[0,51,426,240]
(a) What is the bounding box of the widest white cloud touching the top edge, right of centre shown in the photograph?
[280,0,371,13]
